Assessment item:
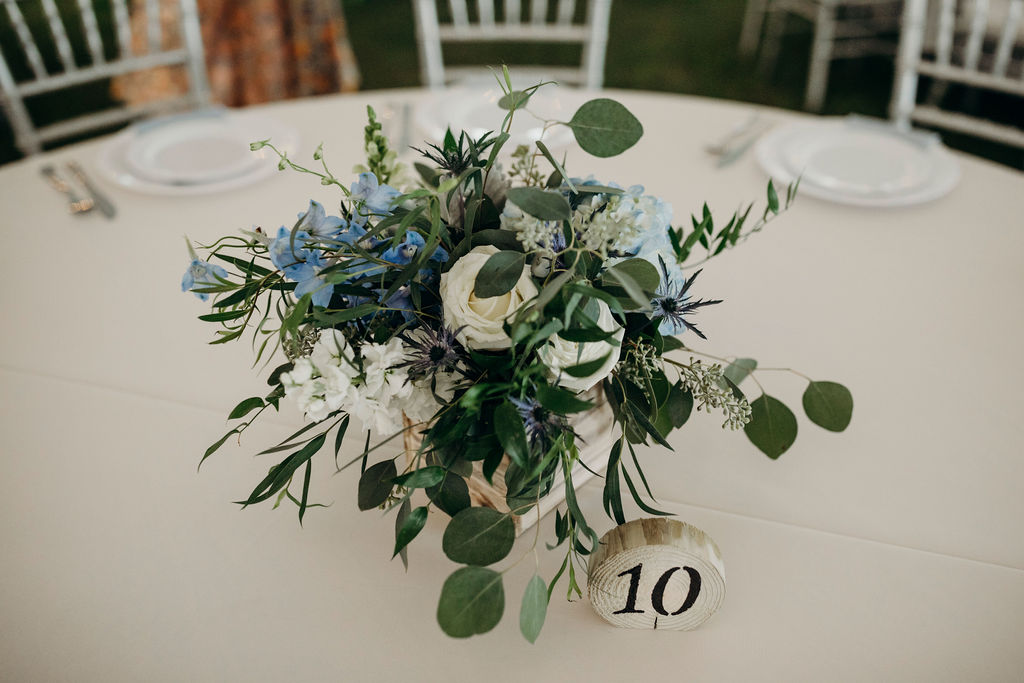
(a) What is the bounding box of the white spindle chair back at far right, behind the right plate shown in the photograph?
[890,0,1024,147]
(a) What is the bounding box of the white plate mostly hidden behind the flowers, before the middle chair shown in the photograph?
[416,84,595,150]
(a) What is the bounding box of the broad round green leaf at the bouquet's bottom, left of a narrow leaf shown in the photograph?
[437,567,505,638]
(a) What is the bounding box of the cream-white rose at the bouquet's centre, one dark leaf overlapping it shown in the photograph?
[440,245,537,349]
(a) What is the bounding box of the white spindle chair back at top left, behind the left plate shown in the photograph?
[0,0,209,155]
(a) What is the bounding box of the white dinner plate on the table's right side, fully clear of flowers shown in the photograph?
[757,117,959,207]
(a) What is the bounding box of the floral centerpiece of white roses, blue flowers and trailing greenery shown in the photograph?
[182,71,852,641]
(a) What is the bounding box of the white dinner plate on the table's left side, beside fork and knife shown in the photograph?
[96,110,299,196]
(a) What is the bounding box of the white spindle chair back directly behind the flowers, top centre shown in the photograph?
[413,0,611,89]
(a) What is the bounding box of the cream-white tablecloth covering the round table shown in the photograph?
[0,91,1024,681]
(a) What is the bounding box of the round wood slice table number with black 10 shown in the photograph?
[587,517,725,631]
